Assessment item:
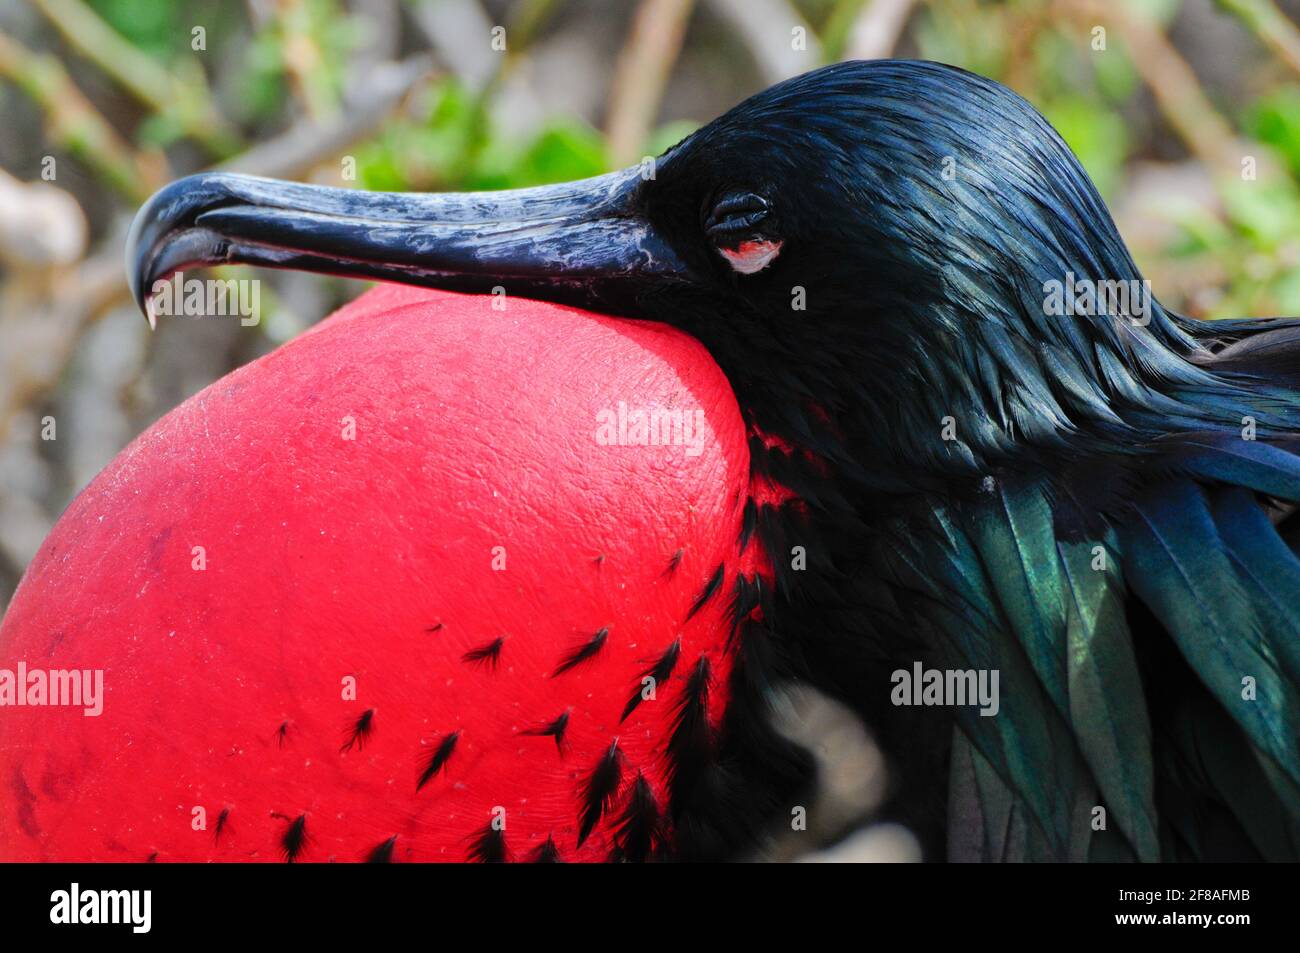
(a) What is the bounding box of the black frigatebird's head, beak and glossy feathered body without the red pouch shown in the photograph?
[127,61,1300,861]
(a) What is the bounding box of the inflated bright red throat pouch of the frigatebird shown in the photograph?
[0,286,759,862]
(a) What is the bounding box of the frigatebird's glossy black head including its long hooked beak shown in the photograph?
[127,61,1211,486]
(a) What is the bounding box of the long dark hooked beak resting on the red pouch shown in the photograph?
[126,166,686,325]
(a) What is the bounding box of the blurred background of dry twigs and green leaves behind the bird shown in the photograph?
[0,0,1300,859]
